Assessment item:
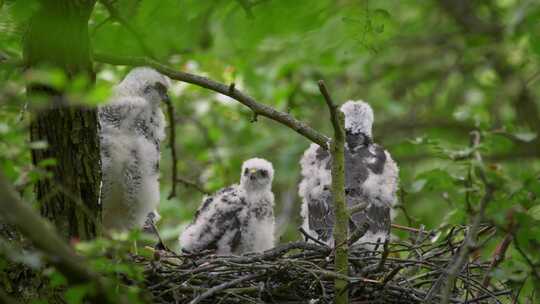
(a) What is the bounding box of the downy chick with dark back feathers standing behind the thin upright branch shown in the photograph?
[298,100,399,248]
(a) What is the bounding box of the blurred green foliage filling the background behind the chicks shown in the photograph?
[0,0,540,303]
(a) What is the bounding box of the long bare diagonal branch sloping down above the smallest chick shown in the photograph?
[94,53,329,149]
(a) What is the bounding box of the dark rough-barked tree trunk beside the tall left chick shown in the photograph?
[24,0,101,239]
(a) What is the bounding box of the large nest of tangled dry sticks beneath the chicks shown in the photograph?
[137,227,511,304]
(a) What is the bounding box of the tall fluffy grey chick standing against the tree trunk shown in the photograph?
[98,67,171,231]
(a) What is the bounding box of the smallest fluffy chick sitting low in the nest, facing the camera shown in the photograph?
[179,158,275,255]
